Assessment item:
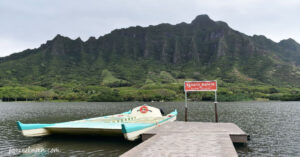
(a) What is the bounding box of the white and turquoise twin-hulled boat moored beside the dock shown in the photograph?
[17,105,177,141]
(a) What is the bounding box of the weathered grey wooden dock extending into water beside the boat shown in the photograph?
[121,121,248,157]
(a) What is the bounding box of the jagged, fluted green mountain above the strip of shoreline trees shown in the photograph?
[0,15,300,101]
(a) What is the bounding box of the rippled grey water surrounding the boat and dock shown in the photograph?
[0,102,300,157]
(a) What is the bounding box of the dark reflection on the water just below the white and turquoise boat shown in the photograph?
[19,135,140,157]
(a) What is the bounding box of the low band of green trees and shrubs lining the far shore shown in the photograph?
[0,83,300,101]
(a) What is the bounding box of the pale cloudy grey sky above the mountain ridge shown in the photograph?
[0,0,300,56]
